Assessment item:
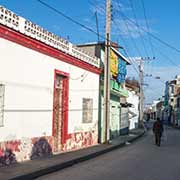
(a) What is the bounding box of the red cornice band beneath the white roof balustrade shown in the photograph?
[0,25,101,74]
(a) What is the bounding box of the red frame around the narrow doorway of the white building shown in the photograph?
[52,69,69,144]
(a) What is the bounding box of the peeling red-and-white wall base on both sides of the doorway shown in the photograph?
[0,131,98,167]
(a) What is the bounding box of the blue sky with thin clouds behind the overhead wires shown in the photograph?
[0,0,180,103]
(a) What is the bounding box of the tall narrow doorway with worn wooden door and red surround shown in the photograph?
[53,71,68,152]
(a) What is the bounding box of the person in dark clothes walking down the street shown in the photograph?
[153,118,164,146]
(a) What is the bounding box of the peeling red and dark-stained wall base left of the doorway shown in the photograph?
[0,137,52,166]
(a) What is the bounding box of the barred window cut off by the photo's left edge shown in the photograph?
[0,84,5,126]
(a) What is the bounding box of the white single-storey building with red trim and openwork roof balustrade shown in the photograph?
[0,7,101,165]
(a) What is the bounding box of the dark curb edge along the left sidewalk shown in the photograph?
[10,131,145,180]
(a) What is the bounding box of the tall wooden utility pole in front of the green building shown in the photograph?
[103,0,111,143]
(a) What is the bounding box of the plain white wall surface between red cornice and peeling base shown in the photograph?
[0,38,99,141]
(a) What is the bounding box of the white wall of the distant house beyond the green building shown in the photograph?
[127,90,139,130]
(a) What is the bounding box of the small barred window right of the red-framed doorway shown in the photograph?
[82,98,93,123]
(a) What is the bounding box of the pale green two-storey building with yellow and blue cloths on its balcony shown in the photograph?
[78,42,130,142]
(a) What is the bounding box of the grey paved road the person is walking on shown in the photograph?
[39,128,180,180]
